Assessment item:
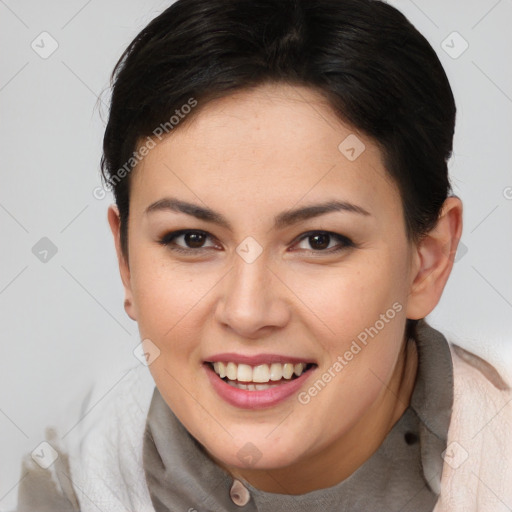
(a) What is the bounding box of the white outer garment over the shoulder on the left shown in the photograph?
[16,364,154,512]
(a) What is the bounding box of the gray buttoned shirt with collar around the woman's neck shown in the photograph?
[143,321,453,512]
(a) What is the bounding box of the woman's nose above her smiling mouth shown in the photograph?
[215,250,291,339]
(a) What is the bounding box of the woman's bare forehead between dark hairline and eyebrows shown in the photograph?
[131,84,400,221]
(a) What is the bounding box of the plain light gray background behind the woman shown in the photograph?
[0,0,512,510]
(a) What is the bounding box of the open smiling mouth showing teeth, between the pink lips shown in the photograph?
[206,362,316,391]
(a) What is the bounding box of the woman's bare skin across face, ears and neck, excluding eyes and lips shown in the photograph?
[108,85,462,494]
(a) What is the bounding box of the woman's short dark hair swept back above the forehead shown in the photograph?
[101,0,456,336]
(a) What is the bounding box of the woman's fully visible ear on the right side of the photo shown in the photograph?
[406,196,462,320]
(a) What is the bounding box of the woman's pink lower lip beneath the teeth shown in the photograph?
[203,364,314,409]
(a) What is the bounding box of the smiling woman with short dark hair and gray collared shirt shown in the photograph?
[18,0,512,512]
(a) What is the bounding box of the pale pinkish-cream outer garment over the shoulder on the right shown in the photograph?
[434,344,512,512]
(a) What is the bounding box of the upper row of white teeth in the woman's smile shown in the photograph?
[213,362,306,382]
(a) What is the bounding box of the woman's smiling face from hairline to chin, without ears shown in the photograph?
[114,85,414,480]
